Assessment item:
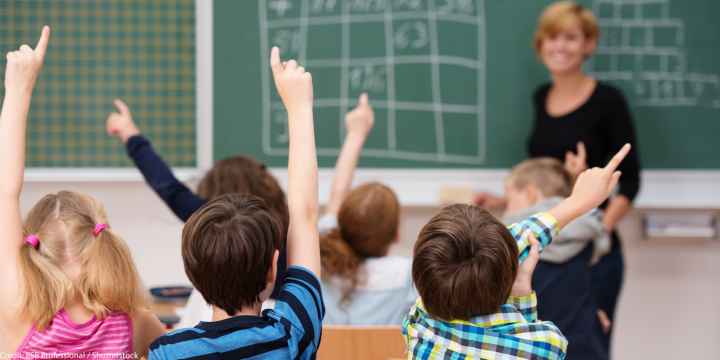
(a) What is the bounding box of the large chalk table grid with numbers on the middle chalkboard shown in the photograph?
[259,0,486,164]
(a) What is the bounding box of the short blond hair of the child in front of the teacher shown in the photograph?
[507,157,573,197]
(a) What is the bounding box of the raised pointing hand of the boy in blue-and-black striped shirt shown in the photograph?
[270,47,313,113]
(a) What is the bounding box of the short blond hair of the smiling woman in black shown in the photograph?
[533,1,600,53]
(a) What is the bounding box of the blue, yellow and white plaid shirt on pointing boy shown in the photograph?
[403,213,567,360]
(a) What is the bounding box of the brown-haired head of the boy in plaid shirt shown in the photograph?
[412,204,518,320]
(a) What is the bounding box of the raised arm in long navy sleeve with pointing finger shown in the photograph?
[106,99,205,221]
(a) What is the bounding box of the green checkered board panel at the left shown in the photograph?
[0,0,197,168]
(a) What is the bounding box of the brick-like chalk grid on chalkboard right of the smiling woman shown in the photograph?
[590,0,720,108]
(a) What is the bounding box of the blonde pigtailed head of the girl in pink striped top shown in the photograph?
[20,191,145,329]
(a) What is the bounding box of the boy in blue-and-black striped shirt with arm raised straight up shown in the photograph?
[150,48,324,359]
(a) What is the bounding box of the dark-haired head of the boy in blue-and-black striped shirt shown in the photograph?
[182,194,283,316]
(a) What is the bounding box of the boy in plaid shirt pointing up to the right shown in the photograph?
[403,145,630,359]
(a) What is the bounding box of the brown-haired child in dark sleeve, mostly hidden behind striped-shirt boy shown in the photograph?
[106,95,288,327]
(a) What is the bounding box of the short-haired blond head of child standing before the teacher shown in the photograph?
[505,158,573,212]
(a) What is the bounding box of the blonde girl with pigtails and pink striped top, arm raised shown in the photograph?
[0,26,165,359]
